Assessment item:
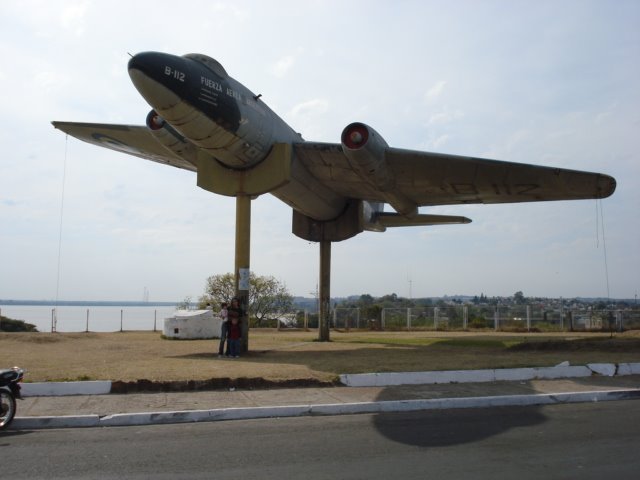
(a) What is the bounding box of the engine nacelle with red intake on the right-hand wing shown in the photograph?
[341,122,395,191]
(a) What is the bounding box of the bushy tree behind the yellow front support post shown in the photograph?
[200,272,293,325]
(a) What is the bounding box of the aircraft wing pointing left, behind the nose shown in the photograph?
[51,122,196,172]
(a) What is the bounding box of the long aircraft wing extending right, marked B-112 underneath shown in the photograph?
[294,142,616,206]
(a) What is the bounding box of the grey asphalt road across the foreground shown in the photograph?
[0,402,640,480]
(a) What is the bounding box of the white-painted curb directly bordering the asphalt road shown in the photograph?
[11,389,640,430]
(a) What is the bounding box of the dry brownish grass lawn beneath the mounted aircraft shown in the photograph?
[0,329,640,382]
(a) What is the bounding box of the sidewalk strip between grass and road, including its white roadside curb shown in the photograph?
[11,374,640,430]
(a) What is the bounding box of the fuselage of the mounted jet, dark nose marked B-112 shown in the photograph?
[128,52,348,221]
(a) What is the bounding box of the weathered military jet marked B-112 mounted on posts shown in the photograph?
[53,52,616,339]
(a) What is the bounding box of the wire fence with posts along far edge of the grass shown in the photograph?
[6,304,640,332]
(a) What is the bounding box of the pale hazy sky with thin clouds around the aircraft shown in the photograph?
[0,0,640,301]
